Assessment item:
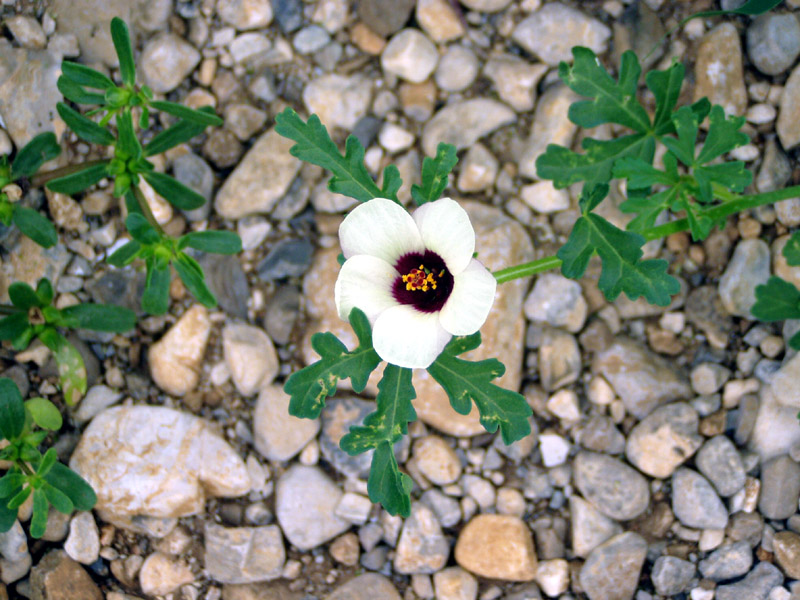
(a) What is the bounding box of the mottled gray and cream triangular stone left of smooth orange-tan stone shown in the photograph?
[394,502,450,575]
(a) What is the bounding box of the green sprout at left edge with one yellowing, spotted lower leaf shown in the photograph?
[0,278,136,405]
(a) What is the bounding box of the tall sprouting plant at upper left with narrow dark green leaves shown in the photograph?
[34,18,242,314]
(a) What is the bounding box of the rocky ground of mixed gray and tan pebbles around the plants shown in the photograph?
[0,0,800,600]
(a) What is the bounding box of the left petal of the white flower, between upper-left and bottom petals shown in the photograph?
[333,254,397,323]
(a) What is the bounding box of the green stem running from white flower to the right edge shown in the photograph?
[492,185,800,283]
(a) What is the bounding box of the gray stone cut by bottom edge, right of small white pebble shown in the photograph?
[580,531,647,600]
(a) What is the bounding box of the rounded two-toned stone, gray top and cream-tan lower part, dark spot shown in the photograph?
[625,402,703,479]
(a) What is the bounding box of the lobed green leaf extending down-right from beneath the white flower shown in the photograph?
[428,332,532,444]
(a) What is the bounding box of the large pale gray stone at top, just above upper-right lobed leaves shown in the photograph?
[511,2,611,66]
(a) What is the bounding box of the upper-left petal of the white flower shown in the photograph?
[339,198,424,264]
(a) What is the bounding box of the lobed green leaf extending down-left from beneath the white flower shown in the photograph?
[283,308,381,419]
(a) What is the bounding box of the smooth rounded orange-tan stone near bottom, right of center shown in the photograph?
[455,514,537,581]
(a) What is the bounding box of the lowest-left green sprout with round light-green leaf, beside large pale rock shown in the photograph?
[0,377,97,538]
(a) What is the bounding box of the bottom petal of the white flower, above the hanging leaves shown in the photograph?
[372,305,452,369]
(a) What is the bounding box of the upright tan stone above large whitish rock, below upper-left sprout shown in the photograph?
[148,304,211,396]
